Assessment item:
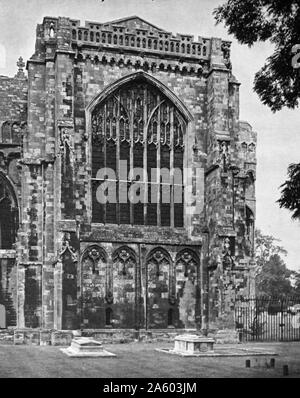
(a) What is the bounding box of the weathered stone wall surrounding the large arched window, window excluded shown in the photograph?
[0,17,256,330]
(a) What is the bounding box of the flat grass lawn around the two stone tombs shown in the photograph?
[0,342,300,378]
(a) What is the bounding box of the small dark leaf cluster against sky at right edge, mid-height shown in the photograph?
[278,163,300,219]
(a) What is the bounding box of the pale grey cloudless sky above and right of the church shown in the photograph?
[0,0,300,269]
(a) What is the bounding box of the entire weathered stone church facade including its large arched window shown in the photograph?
[0,17,256,338]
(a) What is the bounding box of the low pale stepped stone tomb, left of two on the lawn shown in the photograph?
[60,337,116,358]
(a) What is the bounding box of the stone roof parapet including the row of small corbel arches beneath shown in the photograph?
[31,17,231,74]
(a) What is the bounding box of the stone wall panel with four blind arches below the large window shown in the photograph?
[80,242,200,329]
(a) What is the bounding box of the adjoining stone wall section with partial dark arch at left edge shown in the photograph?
[0,63,28,327]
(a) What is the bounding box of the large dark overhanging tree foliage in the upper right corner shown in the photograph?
[214,0,300,112]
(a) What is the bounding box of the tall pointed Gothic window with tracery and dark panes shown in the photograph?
[92,78,186,227]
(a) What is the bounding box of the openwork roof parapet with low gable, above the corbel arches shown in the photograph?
[35,16,231,63]
